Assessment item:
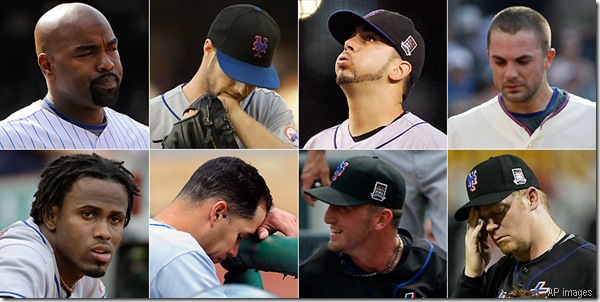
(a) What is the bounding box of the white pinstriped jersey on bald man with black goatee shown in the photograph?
[0,100,150,149]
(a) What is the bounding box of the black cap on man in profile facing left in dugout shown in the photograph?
[304,156,406,209]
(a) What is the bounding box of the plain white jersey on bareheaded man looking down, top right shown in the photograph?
[448,94,596,149]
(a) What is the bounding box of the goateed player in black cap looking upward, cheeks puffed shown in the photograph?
[304,9,447,149]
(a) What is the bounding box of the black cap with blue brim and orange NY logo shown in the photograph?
[208,4,281,89]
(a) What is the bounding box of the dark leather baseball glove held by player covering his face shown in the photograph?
[161,94,239,149]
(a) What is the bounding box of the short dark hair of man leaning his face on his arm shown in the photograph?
[177,156,273,219]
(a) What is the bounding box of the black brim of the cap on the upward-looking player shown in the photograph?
[328,10,400,52]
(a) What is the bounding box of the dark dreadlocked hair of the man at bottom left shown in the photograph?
[30,153,140,226]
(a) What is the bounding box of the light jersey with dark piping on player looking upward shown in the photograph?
[304,112,447,149]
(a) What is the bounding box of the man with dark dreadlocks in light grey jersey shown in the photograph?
[0,154,139,298]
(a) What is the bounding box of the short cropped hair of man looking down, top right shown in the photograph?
[487,6,552,53]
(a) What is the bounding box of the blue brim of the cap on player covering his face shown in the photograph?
[217,49,279,89]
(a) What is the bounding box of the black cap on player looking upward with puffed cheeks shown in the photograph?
[329,9,425,86]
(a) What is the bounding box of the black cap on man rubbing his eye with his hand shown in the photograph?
[454,154,540,221]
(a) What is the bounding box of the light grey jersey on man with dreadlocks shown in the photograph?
[0,217,106,298]
